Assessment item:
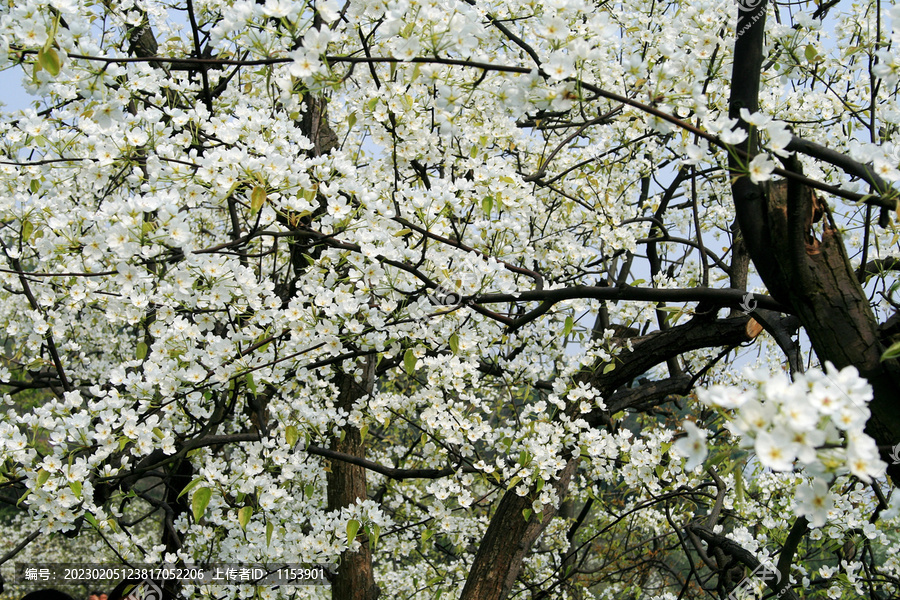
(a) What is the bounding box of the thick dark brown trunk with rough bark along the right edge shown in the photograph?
[730,1,900,484]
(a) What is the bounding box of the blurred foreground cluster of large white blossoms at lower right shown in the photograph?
[673,363,887,527]
